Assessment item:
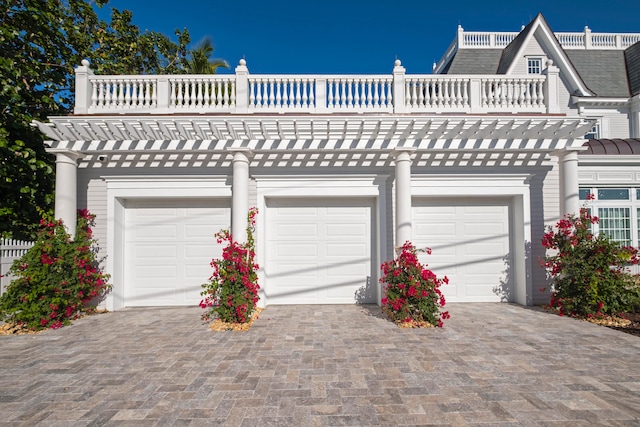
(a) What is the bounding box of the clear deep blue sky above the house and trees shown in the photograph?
[99,0,640,74]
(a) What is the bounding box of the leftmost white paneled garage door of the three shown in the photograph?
[124,199,230,307]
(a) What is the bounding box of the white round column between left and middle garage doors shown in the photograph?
[231,150,250,243]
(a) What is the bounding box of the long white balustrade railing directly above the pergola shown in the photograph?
[74,60,558,114]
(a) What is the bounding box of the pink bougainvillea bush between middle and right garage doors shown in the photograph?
[380,241,449,327]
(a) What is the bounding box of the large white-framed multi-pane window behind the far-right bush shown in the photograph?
[579,187,640,246]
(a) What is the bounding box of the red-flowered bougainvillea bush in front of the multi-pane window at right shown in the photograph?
[542,209,640,317]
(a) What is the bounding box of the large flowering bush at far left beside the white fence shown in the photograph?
[0,211,110,330]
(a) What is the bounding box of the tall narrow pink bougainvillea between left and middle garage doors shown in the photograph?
[200,208,260,323]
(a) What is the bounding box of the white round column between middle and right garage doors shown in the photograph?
[392,150,412,247]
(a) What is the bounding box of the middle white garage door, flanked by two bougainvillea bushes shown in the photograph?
[264,199,375,304]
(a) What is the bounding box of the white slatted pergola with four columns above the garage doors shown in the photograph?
[35,114,592,243]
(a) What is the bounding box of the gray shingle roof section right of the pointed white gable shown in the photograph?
[565,50,628,98]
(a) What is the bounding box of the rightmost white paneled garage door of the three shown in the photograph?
[412,198,513,302]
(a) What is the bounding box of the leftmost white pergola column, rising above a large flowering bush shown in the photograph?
[50,150,82,239]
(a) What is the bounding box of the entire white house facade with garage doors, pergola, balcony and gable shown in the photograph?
[37,15,640,310]
